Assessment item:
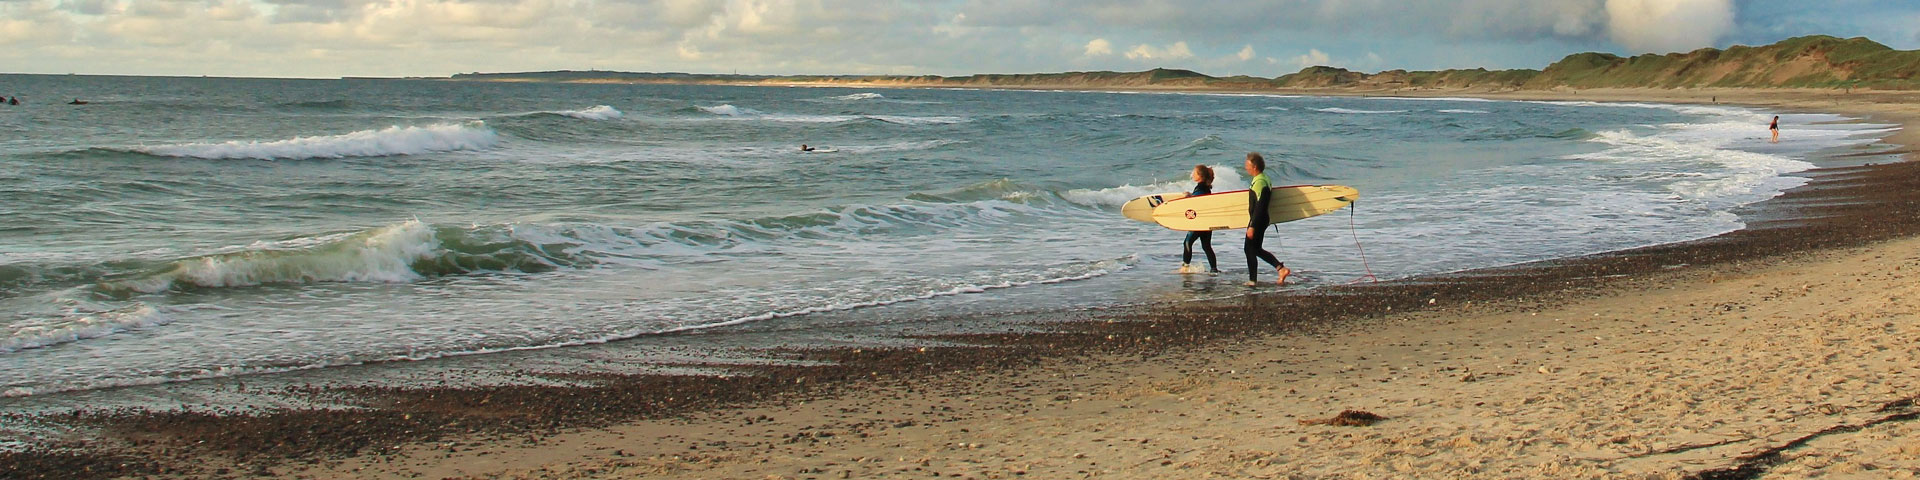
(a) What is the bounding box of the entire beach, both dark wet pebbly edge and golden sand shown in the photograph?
[0,90,1920,478]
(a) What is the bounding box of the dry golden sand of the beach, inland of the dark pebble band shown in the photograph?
[247,90,1920,478]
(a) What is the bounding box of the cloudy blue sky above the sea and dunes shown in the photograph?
[0,0,1920,79]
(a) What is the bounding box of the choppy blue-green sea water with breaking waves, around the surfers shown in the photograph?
[0,75,1889,399]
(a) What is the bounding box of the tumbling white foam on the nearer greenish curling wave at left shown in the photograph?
[108,221,440,294]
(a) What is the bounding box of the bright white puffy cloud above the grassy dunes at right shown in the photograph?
[1607,0,1734,54]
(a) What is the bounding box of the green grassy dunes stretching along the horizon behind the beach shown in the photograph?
[441,35,1920,90]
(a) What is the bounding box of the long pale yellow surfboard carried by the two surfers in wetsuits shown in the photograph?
[1154,184,1359,232]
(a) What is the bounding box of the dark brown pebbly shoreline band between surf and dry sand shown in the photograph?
[0,86,1920,478]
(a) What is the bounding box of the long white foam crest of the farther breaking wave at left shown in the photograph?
[132,121,499,159]
